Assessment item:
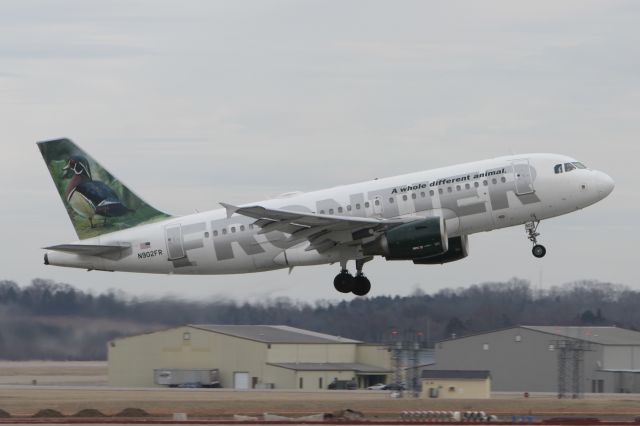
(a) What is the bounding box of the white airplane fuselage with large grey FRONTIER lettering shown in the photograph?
[47,154,613,274]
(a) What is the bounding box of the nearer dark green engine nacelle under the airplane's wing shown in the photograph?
[362,217,449,260]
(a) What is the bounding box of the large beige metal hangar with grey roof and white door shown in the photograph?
[108,325,392,390]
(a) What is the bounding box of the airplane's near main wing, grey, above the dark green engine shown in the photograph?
[220,203,408,253]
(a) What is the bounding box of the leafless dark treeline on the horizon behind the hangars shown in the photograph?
[0,279,640,359]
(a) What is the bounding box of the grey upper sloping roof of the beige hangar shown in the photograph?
[190,324,361,343]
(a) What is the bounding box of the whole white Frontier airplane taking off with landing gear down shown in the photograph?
[37,139,615,296]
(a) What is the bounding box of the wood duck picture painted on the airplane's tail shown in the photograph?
[63,155,132,228]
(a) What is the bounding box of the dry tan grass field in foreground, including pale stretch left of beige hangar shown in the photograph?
[0,362,640,418]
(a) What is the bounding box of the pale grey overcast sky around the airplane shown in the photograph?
[0,0,640,301]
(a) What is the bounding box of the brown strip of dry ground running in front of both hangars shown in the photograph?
[0,386,640,418]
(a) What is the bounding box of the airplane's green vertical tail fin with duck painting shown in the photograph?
[38,139,171,239]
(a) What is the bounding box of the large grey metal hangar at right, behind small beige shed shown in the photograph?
[423,326,640,393]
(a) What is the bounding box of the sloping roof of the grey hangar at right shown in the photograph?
[522,325,640,346]
